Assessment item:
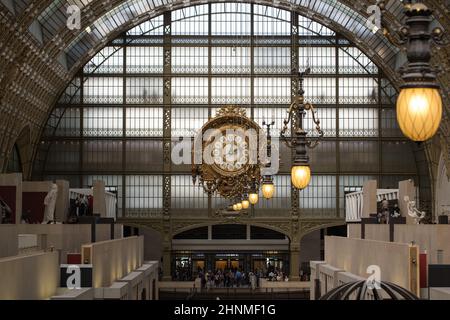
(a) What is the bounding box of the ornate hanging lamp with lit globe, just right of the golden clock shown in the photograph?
[280,68,323,190]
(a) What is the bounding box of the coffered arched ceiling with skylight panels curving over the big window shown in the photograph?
[0,0,450,175]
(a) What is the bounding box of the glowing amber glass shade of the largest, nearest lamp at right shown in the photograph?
[397,88,442,141]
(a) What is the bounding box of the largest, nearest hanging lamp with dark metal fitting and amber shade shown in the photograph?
[397,3,443,142]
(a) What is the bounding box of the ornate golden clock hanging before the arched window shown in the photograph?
[192,106,261,198]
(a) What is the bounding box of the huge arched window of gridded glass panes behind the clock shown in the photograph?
[35,3,418,218]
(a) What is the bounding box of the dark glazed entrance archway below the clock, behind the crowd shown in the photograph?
[171,224,290,285]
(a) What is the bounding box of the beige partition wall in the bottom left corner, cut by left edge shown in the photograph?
[0,252,59,300]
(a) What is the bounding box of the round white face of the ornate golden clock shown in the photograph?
[212,132,248,173]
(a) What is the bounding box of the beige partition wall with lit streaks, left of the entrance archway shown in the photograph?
[81,236,144,288]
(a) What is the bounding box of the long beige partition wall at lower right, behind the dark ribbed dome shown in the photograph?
[325,236,419,295]
